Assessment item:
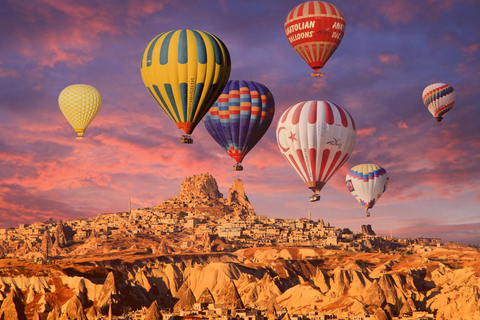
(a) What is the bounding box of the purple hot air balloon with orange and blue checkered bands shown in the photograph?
[203,80,275,170]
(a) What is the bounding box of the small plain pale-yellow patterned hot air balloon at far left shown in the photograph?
[58,84,102,139]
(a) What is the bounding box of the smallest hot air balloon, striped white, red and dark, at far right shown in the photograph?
[422,83,455,125]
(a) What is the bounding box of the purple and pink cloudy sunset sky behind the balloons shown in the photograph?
[0,0,480,245]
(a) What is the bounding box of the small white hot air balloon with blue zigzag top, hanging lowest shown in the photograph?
[345,163,388,217]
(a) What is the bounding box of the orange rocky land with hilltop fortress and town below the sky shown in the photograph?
[0,173,480,320]
